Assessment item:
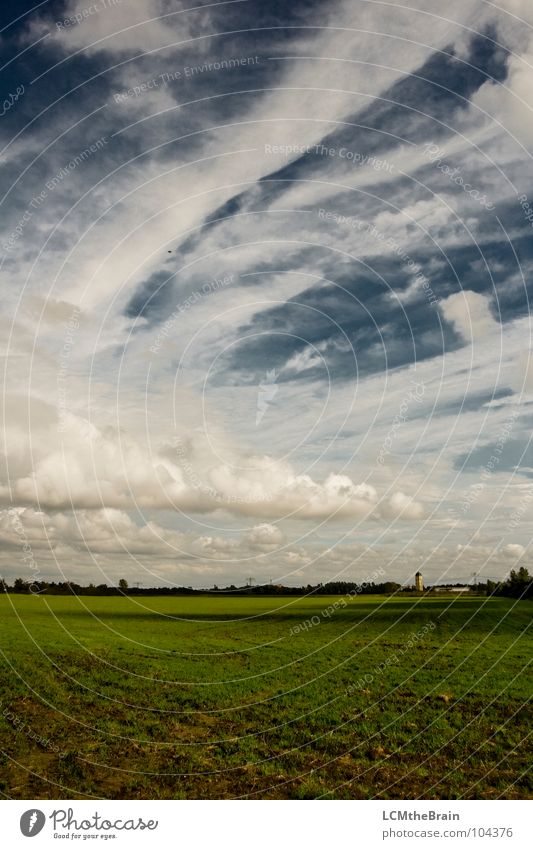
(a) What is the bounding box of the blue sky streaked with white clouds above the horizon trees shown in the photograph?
[0,0,533,587]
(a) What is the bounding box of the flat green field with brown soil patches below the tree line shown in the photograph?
[0,595,533,799]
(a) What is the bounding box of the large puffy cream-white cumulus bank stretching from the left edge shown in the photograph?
[0,402,424,524]
